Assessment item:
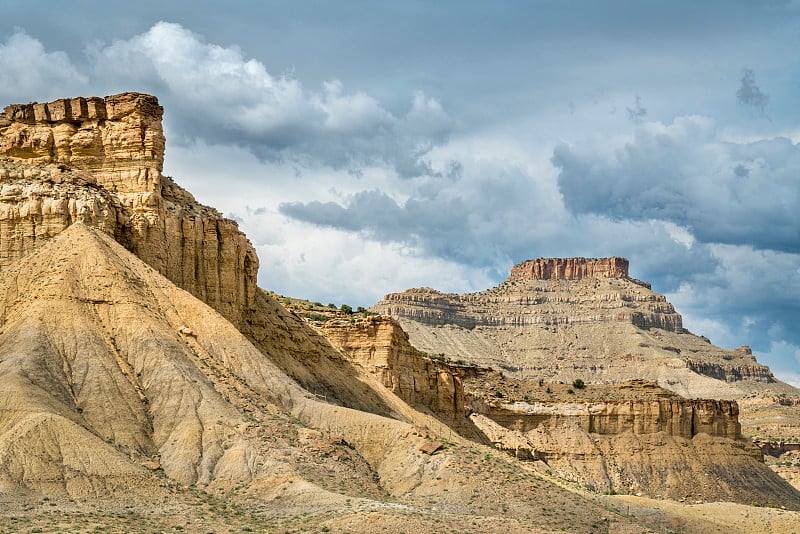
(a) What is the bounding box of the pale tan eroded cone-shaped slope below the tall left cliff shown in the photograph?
[0,223,656,532]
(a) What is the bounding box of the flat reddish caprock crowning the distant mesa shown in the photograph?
[508,257,628,281]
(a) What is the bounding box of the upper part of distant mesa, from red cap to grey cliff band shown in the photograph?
[371,264,683,332]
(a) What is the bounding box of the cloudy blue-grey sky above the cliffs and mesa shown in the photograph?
[0,0,800,386]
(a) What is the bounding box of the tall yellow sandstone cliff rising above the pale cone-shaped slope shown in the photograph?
[0,93,258,324]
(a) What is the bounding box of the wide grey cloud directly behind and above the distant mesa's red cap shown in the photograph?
[280,162,716,291]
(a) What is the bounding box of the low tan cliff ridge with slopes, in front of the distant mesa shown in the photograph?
[320,316,800,507]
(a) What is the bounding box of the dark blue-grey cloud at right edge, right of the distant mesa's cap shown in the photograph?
[552,116,800,251]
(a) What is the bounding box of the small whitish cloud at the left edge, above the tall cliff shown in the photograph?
[0,29,88,103]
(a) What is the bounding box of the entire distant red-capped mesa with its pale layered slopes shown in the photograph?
[371,258,797,399]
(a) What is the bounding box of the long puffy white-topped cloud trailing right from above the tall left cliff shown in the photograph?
[91,22,452,177]
